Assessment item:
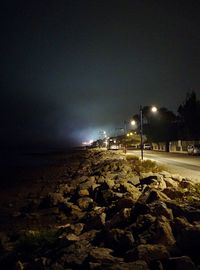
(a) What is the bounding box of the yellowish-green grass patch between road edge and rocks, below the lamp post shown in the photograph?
[126,155,165,174]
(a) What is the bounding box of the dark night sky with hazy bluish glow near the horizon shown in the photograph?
[0,0,200,148]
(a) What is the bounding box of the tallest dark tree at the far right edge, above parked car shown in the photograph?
[178,91,200,140]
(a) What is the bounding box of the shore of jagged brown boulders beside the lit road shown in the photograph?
[0,150,200,270]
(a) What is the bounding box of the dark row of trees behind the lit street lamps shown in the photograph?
[138,91,200,142]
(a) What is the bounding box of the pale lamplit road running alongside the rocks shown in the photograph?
[127,150,200,183]
